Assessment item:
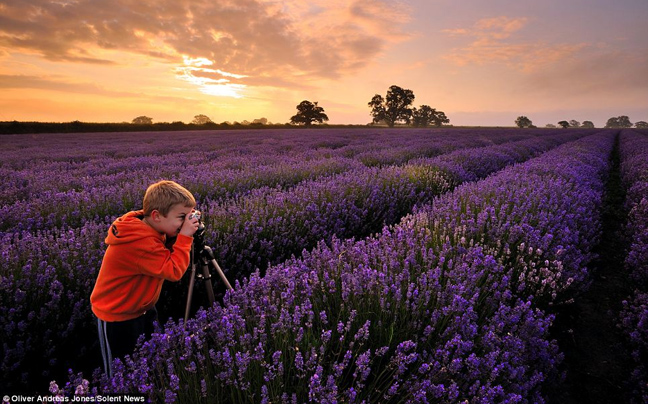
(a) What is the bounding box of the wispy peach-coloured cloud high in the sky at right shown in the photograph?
[442,16,588,72]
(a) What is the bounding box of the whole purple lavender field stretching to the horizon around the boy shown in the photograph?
[0,128,648,403]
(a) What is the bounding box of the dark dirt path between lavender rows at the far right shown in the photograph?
[549,132,632,404]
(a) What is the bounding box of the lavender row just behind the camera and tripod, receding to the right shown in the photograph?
[196,132,584,277]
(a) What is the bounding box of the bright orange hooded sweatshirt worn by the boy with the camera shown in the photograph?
[90,210,193,321]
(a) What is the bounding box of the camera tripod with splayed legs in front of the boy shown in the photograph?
[184,223,232,324]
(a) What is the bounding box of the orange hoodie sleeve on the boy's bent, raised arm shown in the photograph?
[138,234,193,282]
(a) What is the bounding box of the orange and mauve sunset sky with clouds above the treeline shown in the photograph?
[0,0,648,127]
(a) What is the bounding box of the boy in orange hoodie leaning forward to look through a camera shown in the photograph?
[90,181,199,377]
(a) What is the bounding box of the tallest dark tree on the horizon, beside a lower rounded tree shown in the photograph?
[368,86,414,128]
